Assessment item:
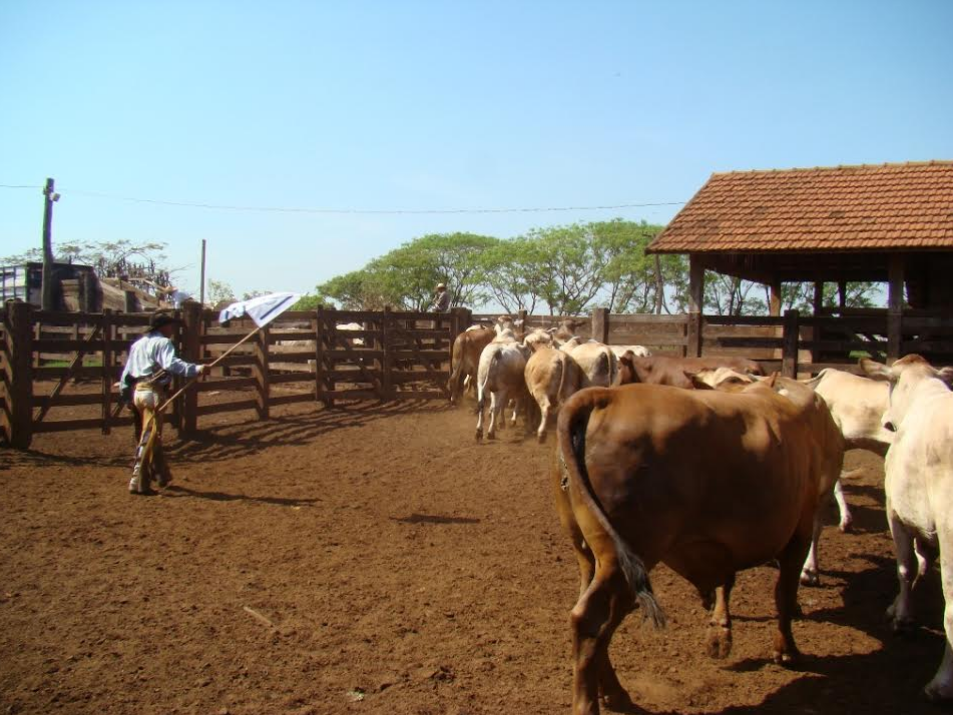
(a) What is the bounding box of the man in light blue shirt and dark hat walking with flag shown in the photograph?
[119,313,205,494]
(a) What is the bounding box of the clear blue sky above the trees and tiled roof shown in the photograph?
[0,0,953,293]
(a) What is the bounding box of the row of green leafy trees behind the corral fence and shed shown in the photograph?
[297,219,876,315]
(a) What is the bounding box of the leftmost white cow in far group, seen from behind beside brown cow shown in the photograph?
[476,328,530,442]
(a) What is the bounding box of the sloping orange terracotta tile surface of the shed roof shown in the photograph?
[649,161,953,253]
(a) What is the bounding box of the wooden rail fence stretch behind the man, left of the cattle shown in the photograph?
[0,303,466,449]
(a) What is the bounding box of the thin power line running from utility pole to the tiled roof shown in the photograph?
[0,184,685,216]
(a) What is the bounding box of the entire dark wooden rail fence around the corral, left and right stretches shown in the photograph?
[0,303,953,448]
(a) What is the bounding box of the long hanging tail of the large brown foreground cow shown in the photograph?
[556,390,665,628]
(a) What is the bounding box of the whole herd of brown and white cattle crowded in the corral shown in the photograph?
[449,318,953,715]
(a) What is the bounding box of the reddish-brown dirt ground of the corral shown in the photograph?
[0,403,943,715]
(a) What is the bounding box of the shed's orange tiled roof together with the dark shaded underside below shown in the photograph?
[648,161,953,310]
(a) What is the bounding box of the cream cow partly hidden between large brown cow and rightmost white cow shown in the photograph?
[807,368,893,531]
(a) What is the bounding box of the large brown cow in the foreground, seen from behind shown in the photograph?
[553,383,826,715]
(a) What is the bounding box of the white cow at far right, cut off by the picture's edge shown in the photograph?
[861,355,953,700]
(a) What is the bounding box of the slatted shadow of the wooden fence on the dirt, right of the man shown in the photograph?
[166,401,449,462]
